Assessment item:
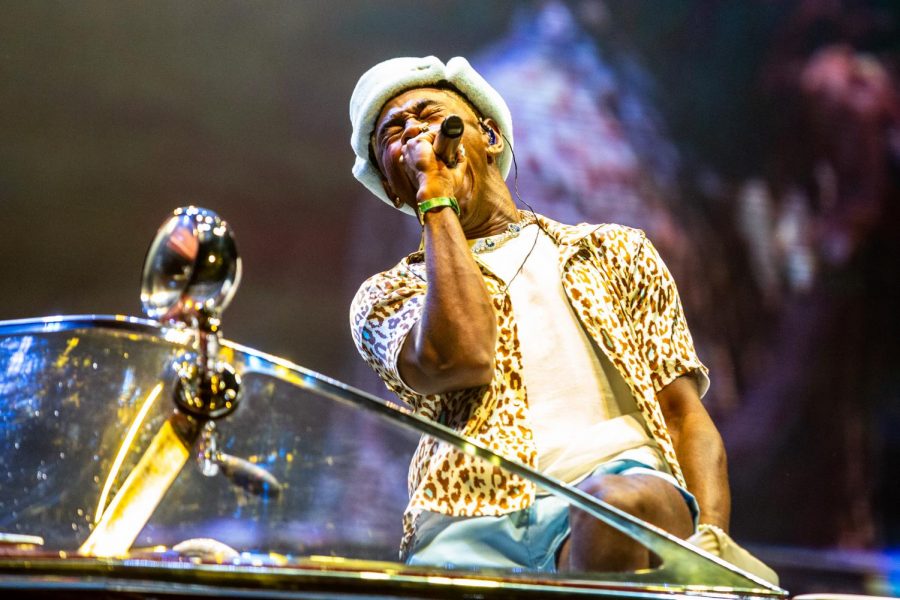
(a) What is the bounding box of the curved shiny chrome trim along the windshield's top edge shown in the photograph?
[0,315,788,597]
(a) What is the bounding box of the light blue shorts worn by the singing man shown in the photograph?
[406,460,700,573]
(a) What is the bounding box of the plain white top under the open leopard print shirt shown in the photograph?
[470,224,669,483]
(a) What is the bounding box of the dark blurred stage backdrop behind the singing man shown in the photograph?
[0,0,900,589]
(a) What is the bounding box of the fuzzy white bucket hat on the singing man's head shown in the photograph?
[350,56,513,215]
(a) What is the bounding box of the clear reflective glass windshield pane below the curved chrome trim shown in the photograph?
[0,322,772,588]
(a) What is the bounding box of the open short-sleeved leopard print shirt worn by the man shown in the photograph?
[350,214,709,548]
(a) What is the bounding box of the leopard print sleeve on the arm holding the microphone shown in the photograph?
[350,269,425,402]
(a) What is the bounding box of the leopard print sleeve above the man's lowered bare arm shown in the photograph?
[629,231,709,397]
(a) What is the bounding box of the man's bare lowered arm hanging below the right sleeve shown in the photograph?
[656,376,731,531]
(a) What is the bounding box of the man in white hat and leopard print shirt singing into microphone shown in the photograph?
[350,56,764,571]
